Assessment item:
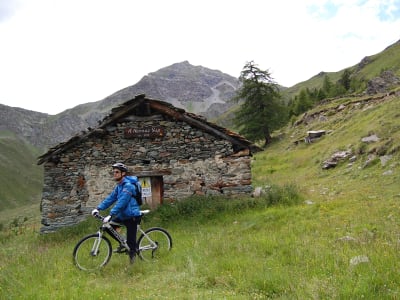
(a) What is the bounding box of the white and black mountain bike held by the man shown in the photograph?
[73,210,172,271]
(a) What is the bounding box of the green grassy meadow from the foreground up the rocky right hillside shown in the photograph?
[0,93,400,299]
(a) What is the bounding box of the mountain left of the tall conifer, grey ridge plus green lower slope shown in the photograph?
[0,61,239,210]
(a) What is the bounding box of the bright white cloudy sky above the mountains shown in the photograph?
[0,0,400,114]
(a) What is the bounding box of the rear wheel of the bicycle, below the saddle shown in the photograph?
[138,227,172,261]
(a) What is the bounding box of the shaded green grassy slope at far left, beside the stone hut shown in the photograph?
[0,131,43,211]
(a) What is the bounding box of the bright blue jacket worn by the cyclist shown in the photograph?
[97,176,140,221]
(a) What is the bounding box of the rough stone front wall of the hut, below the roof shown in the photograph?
[41,116,252,232]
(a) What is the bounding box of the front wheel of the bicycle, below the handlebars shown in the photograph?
[73,234,112,271]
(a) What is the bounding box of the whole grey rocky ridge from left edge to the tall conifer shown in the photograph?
[0,61,239,149]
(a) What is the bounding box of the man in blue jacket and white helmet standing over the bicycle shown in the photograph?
[92,163,140,263]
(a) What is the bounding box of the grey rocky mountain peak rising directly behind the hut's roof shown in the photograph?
[101,61,239,116]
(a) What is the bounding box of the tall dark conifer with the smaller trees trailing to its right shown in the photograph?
[231,61,363,146]
